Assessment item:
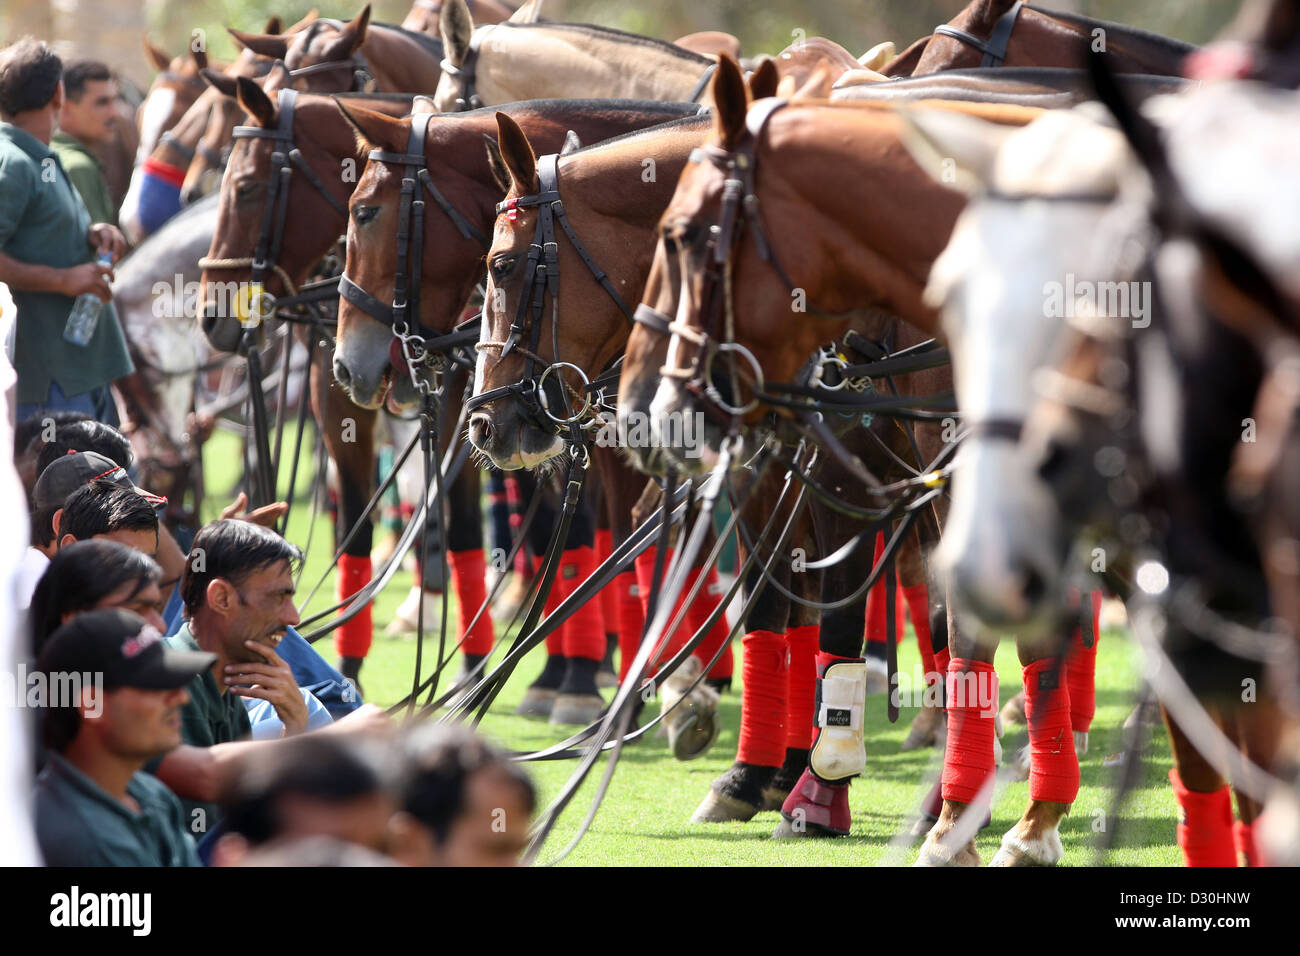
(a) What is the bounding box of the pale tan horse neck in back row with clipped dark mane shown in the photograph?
[476,25,709,103]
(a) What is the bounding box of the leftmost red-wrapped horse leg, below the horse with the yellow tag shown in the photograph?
[311,361,376,682]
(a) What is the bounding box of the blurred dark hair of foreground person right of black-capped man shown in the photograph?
[222,734,391,847]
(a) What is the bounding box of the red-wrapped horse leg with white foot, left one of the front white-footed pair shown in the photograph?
[915,602,997,866]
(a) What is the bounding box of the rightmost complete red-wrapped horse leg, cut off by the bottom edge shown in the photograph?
[1161,708,1236,866]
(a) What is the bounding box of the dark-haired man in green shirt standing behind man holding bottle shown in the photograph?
[49,60,117,222]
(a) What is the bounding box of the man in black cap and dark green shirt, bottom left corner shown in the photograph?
[35,610,216,866]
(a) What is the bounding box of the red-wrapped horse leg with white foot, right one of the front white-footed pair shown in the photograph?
[989,640,1079,866]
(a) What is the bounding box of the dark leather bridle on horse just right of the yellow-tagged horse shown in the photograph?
[338,113,489,393]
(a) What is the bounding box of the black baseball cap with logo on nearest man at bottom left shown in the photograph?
[36,609,217,691]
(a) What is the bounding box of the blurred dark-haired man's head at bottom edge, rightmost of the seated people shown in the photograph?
[390,723,537,866]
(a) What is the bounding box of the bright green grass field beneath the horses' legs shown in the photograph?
[204,421,1182,866]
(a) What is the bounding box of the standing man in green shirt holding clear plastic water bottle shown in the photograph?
[0,39,133,425]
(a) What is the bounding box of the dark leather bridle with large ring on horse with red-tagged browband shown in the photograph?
[465,153,632,444]
